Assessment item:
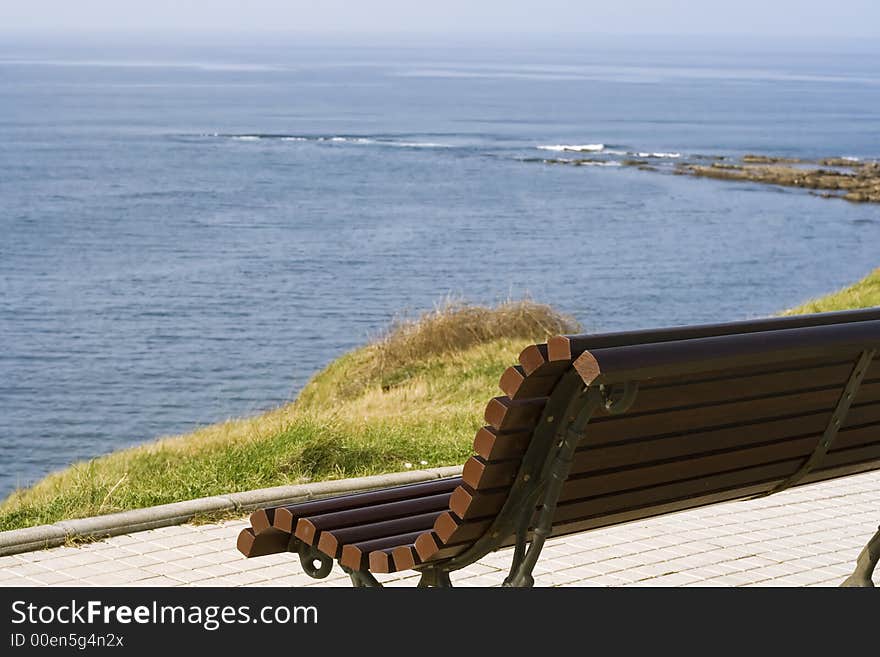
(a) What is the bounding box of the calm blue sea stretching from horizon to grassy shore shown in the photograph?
[0,38,880,494]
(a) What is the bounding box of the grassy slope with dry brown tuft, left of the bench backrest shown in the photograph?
[0,302,578,531]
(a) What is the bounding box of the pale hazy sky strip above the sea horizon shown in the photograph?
[0,0,880,39]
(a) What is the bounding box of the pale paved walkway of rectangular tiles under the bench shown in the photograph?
[0,472,880,586]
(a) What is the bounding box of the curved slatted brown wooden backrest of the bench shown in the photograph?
[416,309,880,563]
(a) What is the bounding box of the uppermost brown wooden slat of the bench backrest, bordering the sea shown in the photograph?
[546,308,880,362]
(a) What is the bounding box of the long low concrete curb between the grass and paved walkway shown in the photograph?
[0,466,461,556]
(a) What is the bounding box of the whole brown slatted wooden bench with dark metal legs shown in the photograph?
[238,308,880,586]
